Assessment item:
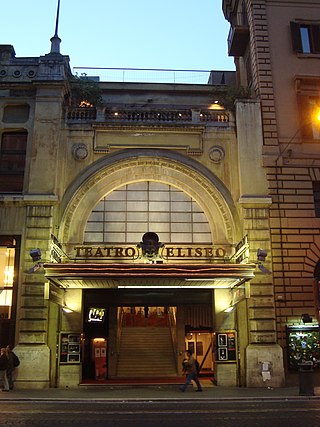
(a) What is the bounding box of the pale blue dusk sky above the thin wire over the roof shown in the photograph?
[0,0,235,70]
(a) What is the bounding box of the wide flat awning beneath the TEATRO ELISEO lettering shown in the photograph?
[44,263,256,289]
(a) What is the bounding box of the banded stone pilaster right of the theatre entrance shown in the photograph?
[240,197,284,387]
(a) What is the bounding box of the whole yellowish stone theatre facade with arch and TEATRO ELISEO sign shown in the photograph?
[0,44,284,388]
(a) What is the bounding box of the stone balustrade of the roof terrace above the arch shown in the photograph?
[66,107,230,126]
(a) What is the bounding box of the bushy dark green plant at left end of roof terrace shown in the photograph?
[70,74,102,107]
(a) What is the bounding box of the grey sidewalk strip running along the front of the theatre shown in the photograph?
[0,384,320,402]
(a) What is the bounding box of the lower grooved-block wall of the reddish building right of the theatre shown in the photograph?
[269,166,320,345]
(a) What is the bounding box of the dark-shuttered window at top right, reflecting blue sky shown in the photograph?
[290,22,320,55]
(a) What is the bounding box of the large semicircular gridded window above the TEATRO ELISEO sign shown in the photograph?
[85,181,212,244]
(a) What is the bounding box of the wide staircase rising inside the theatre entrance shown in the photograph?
[117,327,177,378]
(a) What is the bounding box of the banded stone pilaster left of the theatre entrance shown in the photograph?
[15,205,52,388]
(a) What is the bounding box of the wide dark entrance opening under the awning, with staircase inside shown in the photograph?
[82,289,213,382]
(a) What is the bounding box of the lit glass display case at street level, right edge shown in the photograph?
[287,325,320,369]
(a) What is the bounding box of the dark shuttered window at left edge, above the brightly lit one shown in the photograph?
[0,132,28,193]
